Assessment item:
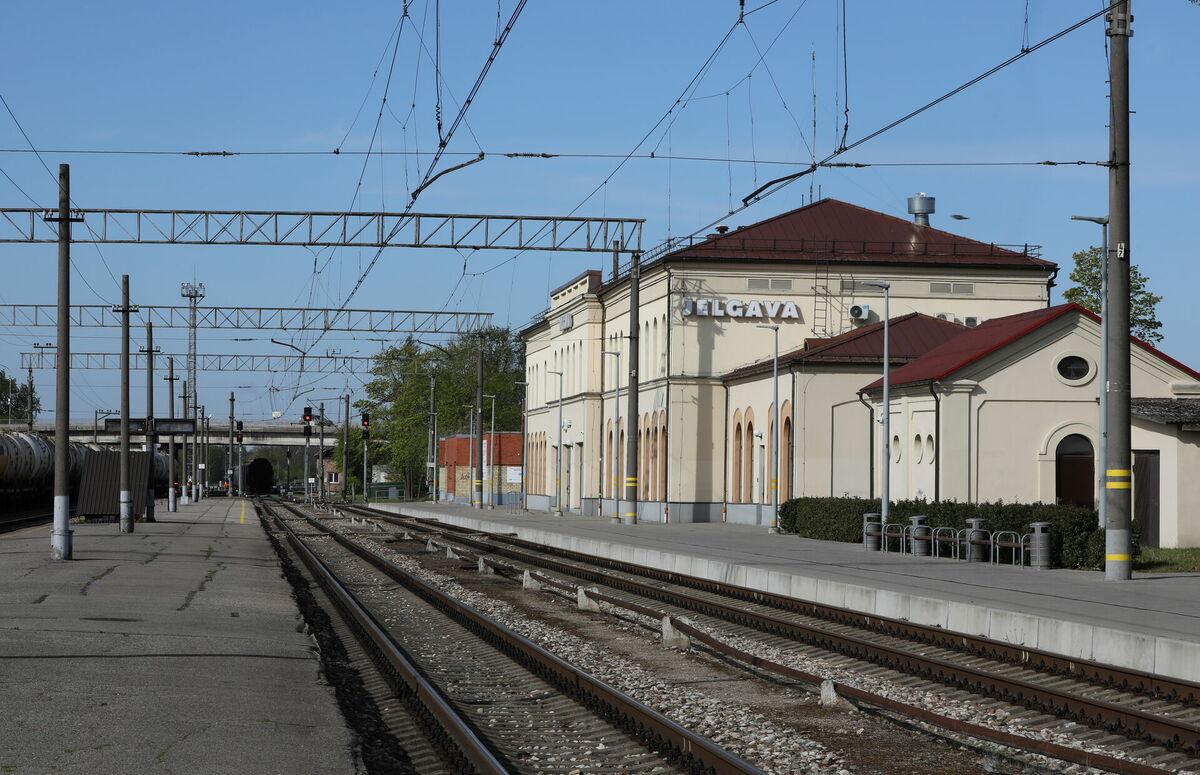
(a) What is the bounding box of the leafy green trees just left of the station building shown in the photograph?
[334,328,524,494]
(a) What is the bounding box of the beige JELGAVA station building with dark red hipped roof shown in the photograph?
[523,199,1190,551]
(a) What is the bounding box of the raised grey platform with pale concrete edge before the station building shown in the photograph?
[372,503,1200,681]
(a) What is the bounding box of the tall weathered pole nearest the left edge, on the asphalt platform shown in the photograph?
[46,164,73,560]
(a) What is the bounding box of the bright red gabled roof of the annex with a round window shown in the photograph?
[863,304,1200,390]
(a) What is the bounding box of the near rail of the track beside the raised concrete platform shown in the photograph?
[345,506,1200,756]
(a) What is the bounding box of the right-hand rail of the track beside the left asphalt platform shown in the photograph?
[281,503,763,775]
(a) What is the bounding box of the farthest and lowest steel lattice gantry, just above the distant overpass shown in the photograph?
[20,350,374,374]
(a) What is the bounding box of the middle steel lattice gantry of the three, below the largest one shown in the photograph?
[0,304,492,334]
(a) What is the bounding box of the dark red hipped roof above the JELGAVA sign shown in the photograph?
[666,199,1056,271]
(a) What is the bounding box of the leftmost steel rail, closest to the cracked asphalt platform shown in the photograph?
[264,506,509,775]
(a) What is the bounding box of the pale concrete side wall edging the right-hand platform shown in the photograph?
[376,504,1200,681]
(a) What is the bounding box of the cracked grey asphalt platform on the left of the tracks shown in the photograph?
[0,498,361,775]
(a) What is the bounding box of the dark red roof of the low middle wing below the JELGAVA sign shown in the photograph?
[725,312,967,379]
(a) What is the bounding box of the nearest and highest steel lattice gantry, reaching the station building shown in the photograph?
[0,208,644,253]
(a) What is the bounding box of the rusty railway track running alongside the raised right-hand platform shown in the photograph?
[337,505,1200,775]
